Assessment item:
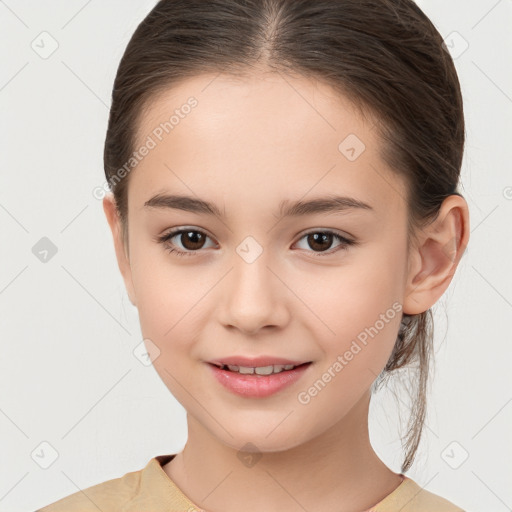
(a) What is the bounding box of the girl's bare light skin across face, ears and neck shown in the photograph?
[103,73,469,512]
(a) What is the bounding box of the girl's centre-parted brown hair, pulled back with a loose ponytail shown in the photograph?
[104,0,465,472]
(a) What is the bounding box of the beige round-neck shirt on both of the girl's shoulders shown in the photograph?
[36,454,464,512]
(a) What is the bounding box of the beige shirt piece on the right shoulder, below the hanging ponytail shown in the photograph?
[369,477,464,512]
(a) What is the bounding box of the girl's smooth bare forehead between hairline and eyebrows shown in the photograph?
[129,74,404,216]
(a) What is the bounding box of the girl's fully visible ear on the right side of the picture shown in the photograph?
[403,195,469,315]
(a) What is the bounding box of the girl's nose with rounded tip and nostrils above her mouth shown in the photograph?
[220,252,291,335]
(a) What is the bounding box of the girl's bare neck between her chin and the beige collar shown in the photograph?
[164,394,402,512]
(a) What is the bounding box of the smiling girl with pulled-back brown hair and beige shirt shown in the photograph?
[37,0,469,512]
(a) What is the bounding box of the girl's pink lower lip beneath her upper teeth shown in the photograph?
[208,363,311,398]
